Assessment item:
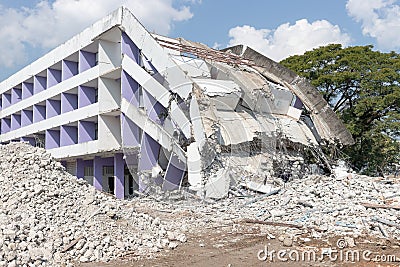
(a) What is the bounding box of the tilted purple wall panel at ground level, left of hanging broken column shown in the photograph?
[162,155,186,191]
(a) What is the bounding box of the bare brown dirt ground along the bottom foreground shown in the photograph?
[83,224,400,267]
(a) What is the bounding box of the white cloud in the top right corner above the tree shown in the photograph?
[346,0,400,49]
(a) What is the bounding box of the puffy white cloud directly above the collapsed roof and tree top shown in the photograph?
[229,19,350,61]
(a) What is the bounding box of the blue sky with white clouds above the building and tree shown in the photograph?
[0,0,400,80]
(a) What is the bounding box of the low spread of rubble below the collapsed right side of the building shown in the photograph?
[137,174,400,240]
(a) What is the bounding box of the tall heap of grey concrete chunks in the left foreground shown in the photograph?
[0,143,186,266]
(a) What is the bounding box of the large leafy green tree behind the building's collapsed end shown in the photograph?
[281,44,400,174]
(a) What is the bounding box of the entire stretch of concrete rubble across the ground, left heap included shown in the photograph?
[0,143,400,266]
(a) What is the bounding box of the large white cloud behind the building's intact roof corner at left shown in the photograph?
[0,0,193,67]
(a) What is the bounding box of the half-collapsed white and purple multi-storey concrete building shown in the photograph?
[0,7,353,198]
